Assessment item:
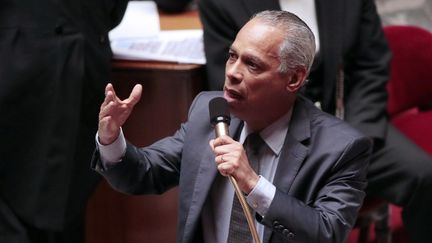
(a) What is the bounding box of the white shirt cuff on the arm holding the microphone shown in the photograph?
[246,176,276,217]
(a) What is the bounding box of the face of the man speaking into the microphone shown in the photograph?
[224,19,289,122]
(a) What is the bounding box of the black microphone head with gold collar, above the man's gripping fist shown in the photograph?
[209,97,231,137]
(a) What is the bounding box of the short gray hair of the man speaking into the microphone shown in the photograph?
[252,10,315,75]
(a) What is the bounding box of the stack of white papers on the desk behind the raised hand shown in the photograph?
[110,1,206,64]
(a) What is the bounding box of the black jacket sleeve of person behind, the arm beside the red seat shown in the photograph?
[344,0,391,142]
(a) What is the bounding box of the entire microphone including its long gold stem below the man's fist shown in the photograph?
[209,97,260,243]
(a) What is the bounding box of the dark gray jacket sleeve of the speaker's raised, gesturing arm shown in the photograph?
[91,93,212,194]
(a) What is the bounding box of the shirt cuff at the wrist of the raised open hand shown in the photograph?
[96,128,126,168]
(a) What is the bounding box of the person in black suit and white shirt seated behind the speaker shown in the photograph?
[199,0,432,242]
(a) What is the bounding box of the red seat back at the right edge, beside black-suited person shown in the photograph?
[385,26,432,154]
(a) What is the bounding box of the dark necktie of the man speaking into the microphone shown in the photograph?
[227,133,264,243]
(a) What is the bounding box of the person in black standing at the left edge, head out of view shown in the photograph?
[0,0,127,243]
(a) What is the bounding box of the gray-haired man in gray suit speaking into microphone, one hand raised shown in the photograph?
[92,11,371,243]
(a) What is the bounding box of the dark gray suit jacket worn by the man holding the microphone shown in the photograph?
[92,92,371,243]
